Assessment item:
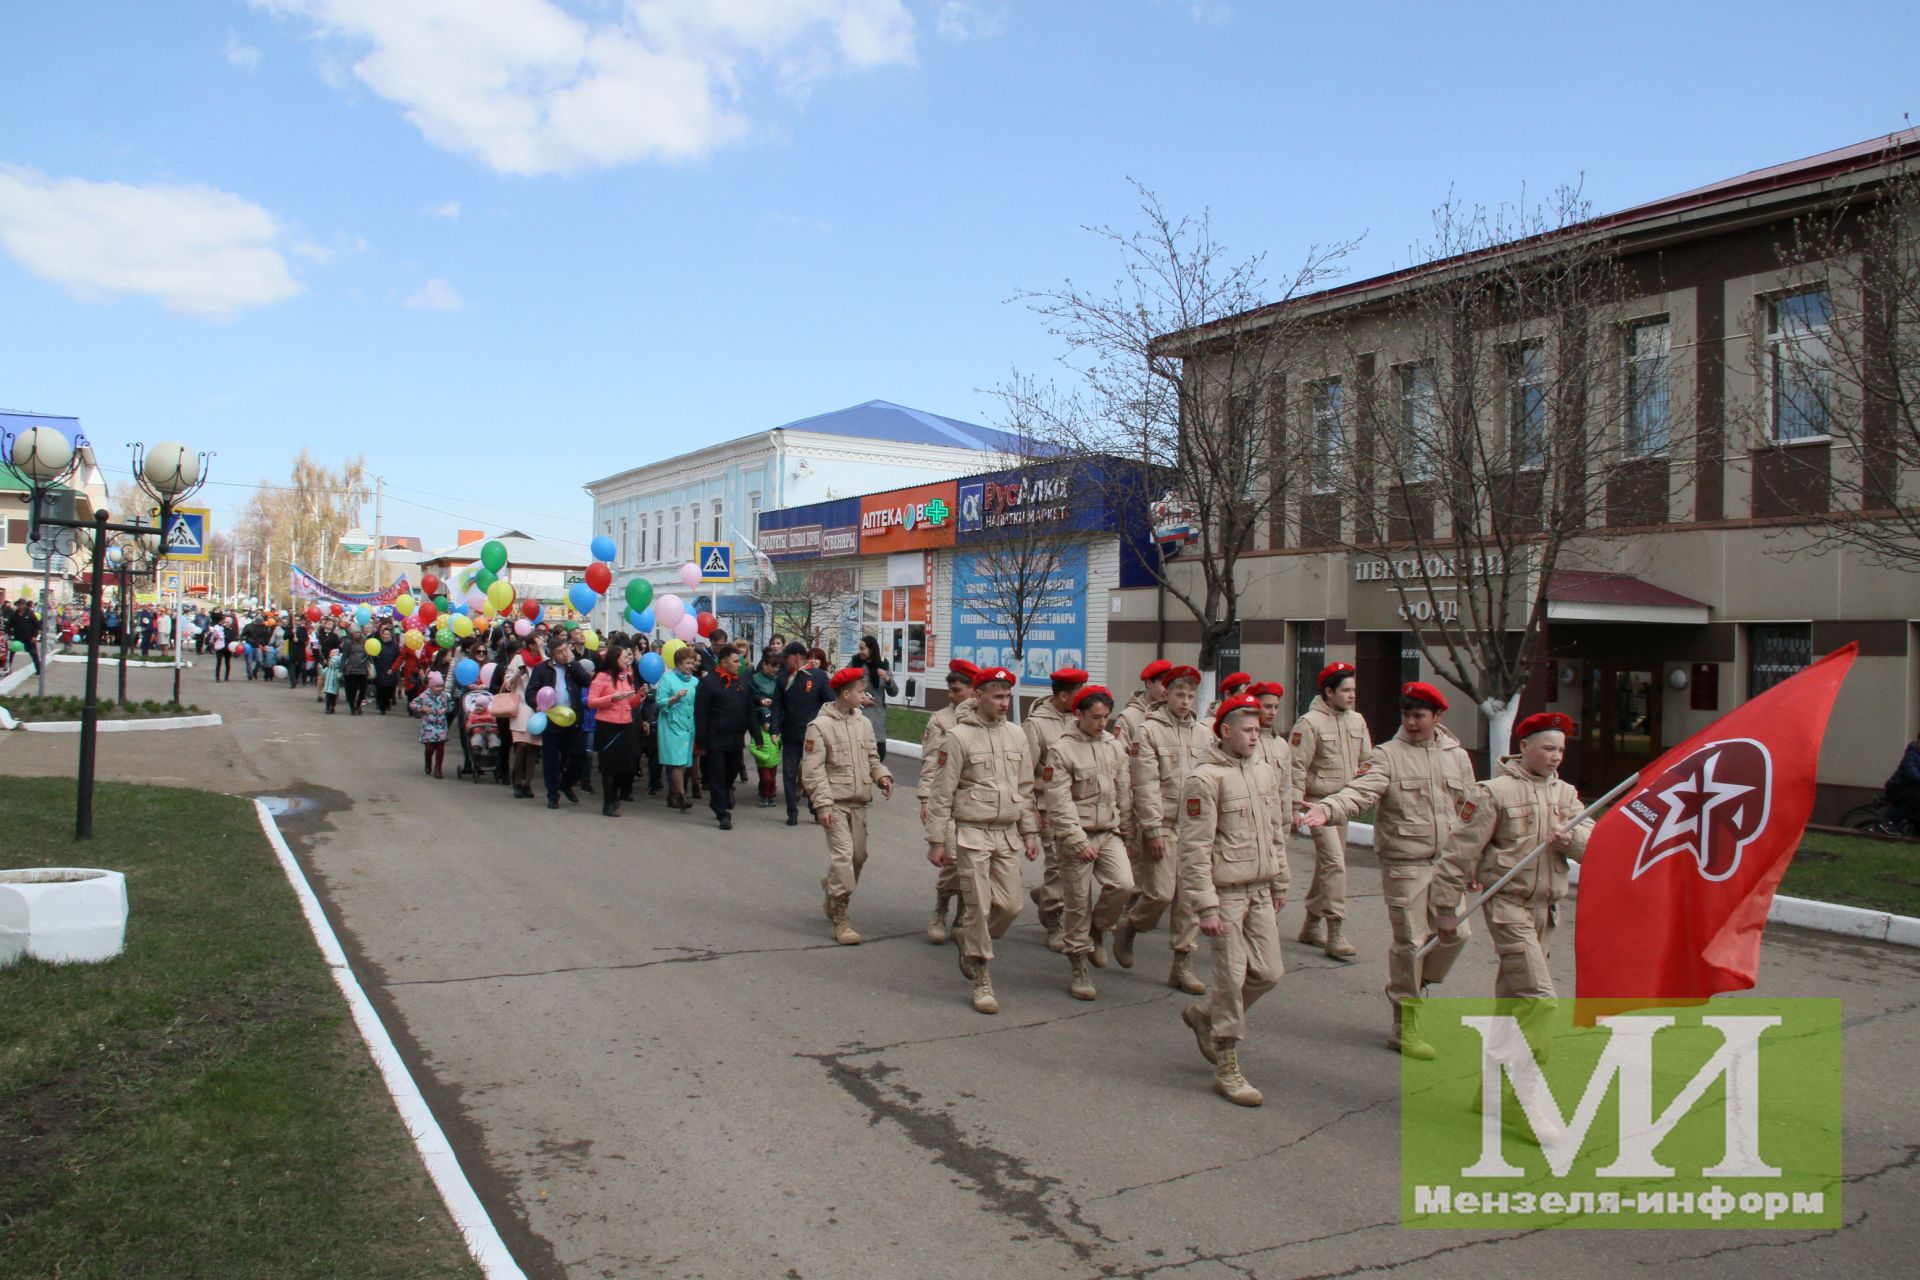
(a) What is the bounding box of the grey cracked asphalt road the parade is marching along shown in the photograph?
[0,666,1920,1280]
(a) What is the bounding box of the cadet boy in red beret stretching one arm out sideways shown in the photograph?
[1306,679,1473,1061]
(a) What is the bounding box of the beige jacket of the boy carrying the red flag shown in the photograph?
[1428,756,1594,912]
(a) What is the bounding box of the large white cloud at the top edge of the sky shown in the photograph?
[250,0,914,175]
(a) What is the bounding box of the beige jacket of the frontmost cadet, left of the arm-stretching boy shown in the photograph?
[1179,745,1292,915]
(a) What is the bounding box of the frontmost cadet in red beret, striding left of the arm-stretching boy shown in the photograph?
[1179,693,1294,1107]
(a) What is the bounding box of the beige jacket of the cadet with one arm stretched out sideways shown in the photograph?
[1317,725,1475,862]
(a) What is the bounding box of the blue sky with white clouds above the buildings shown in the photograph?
[0,0,1920,545]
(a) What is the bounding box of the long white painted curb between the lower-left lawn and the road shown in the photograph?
[253,800,526,1280]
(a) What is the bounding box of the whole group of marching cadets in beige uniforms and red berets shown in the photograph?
[801,660,1592,1107]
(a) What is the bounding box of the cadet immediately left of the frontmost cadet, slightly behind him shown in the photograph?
[1114,666,1213,996]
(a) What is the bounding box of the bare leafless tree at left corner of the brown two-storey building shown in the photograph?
[1002,182,1357,672]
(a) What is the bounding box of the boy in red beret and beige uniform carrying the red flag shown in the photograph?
[1428,712,1594,1043]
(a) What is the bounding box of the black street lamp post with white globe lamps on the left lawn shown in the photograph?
[0,426,211,841]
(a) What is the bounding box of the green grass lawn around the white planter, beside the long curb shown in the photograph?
[0,777,478,1280]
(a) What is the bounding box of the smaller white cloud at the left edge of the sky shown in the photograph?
[0,165,301,320]
